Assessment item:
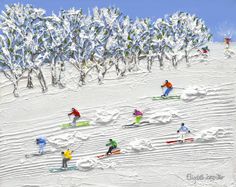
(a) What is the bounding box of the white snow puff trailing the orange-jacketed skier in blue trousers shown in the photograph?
[181,86,207,101]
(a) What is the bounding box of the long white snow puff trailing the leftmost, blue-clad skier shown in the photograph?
[48,132,89,147]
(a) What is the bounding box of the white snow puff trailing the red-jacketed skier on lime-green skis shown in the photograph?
[96,110,119,124]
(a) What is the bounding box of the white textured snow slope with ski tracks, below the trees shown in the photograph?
[0,44,236,187]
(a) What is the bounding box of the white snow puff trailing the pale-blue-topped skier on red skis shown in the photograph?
[195,127,228,142]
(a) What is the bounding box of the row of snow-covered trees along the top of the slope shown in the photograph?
[0,4,211,96]
